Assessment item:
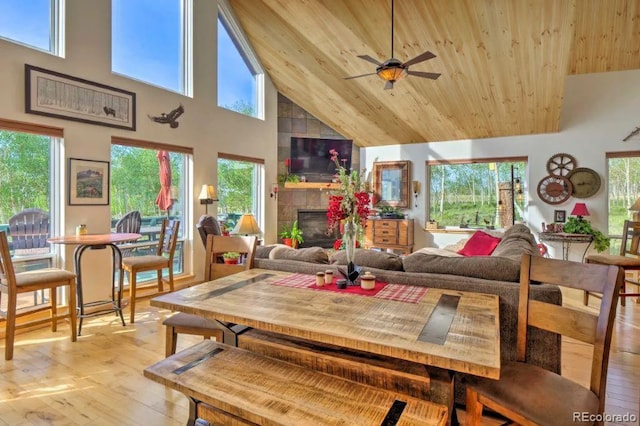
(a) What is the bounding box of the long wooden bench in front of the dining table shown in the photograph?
[144,340,448,426]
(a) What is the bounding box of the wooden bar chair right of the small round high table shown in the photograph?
[120,219,180,324]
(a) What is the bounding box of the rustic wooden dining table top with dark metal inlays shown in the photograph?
[151,269,500,424]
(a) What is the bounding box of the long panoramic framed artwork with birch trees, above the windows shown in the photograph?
[25,64,136,130]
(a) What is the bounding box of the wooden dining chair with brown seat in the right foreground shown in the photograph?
[465,254,624,426]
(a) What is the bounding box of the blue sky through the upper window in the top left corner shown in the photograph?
[0,0,51,51]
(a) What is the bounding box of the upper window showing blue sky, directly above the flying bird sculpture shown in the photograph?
[111,0,193,96]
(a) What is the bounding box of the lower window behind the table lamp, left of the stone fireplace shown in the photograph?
[218,153,264,231]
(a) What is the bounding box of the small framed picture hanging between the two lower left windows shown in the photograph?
[68,158,109,206]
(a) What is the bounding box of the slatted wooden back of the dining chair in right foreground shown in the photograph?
[517,254,624,404]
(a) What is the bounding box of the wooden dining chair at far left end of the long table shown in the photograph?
[163,234,257,357]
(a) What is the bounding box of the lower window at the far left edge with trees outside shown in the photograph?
[0,120,65,310]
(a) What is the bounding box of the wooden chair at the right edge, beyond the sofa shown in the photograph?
[583,220,640,306]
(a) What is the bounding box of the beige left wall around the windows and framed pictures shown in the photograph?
[0,0,277,300]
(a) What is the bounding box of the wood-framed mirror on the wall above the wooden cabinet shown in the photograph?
[373,161,411,208]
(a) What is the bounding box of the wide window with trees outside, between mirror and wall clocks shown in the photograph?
[427,158,527,229]
